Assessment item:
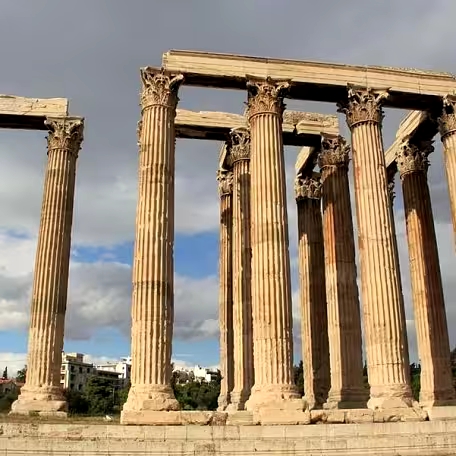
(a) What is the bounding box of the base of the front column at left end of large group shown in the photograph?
[122,385,180,412]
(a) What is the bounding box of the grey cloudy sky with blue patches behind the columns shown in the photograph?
[0,0,456,373]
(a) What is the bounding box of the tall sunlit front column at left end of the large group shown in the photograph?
[121,68,183,423]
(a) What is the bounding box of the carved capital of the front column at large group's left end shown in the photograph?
[141,67,184,109]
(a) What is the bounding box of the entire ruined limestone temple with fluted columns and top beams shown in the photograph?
[8,51,456,442]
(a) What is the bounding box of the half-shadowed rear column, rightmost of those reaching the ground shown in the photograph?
[396,141,455,406]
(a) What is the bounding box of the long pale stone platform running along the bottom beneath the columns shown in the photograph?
[0,421,456,456]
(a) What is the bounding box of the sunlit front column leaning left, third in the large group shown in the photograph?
[339,87,412,409]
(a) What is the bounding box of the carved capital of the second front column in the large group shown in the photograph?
[247,77,290,119]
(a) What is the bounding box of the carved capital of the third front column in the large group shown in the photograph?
[337,85,389,130]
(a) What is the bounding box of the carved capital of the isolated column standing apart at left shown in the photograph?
[44,117,84,157]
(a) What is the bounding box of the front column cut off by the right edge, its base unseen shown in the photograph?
[438,95,456,245]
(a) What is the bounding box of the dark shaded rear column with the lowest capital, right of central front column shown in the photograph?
[295,174,330,409]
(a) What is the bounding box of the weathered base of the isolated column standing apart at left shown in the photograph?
[10,385,68,418]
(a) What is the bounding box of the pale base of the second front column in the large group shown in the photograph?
[245,385,307,412]
